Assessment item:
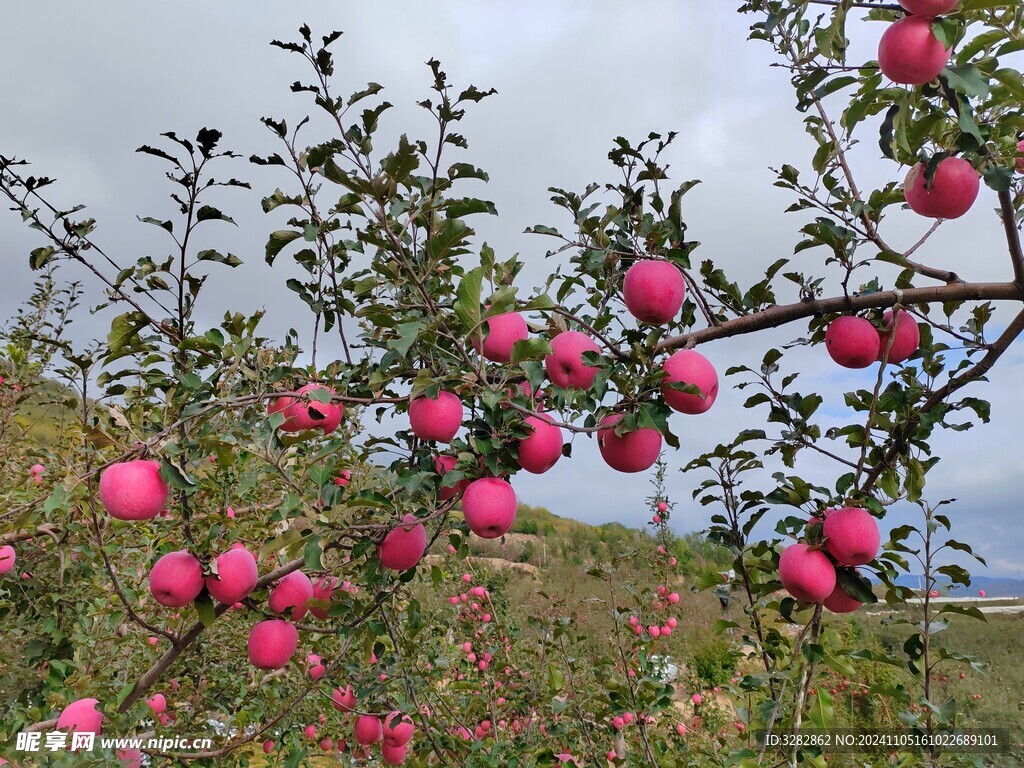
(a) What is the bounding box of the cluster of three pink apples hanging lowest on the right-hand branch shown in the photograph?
[778,507,882,613]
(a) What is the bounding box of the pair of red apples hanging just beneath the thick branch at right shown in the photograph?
[825,309,921,369]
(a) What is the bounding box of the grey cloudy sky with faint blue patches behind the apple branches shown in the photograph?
[0,0,1024,577]
